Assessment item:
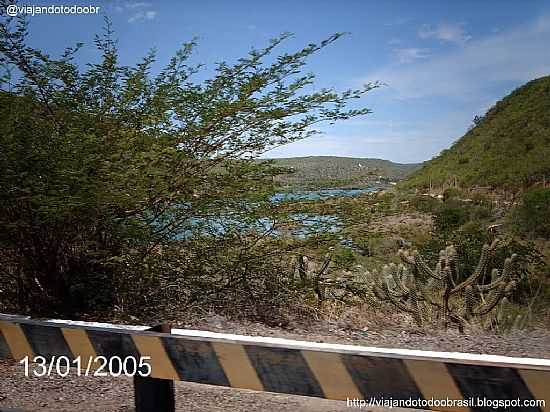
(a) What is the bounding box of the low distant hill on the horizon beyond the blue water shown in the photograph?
[264,156,419,187]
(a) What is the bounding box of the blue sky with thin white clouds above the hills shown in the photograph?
[6,0,550,163]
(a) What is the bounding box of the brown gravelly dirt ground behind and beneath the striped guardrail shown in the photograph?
[0,316,550,412]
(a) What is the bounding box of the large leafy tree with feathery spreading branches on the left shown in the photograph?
[0,11,377,314]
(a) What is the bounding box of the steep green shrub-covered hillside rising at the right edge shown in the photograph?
[402,76,550,190]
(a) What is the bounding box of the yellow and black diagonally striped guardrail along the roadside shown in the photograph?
[0,315,550,411]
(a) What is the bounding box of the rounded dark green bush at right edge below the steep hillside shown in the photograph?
[511,187,550,239]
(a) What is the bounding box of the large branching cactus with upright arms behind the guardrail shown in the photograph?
[372,241,519,332]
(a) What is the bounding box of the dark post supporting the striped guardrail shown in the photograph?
[134,323,176,412]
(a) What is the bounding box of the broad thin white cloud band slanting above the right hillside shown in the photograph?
[364,15,550,99]
